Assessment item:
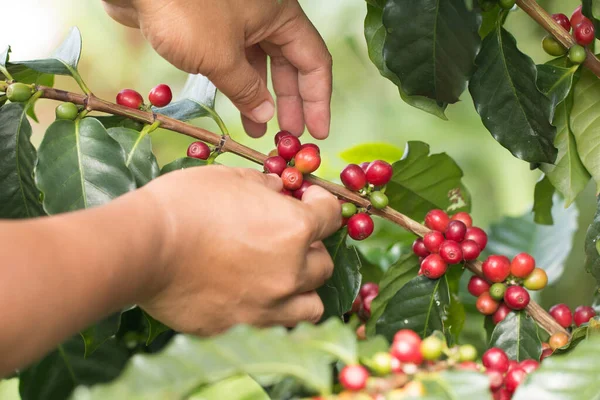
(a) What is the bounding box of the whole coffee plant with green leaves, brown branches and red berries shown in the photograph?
[0,0,600,400]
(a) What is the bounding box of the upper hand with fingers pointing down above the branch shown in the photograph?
[104,0,332,139]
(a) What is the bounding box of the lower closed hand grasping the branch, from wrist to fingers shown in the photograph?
[138,166,341,335]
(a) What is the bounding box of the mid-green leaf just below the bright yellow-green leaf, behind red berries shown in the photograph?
[386,141,470,221]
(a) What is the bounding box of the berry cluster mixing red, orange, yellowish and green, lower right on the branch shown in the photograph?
[468,253,548,324]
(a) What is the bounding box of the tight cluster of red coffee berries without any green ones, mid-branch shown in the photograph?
[412,210,487,279]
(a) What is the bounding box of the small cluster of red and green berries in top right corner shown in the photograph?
[542,6,595,64]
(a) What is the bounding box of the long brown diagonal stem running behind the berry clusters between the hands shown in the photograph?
[37,86,567,334]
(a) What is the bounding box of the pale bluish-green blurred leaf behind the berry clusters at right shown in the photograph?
[486,196,579,284]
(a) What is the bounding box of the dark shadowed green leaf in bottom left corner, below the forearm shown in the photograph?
[19,336,129,400]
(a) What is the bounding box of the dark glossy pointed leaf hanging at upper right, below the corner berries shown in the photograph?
[469,24,557,163]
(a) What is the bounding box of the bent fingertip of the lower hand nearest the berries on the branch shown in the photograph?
[302,185,342,242]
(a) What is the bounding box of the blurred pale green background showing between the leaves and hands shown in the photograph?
[0,0,596,306]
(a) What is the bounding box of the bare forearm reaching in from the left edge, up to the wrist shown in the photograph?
[0,189,162,375]
